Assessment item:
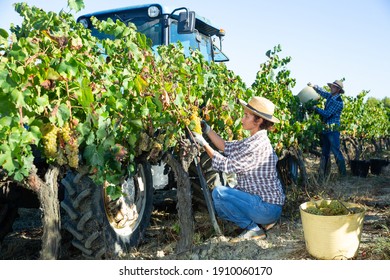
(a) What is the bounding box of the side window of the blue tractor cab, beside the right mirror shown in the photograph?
[170,21,213,61]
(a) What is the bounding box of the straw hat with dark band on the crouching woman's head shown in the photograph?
[239,96,280,123]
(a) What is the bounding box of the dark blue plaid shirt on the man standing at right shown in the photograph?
[314,86,344,125]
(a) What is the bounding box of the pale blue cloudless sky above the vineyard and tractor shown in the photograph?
[0,0,390,99]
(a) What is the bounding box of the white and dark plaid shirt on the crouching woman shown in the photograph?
[212,130,285,205]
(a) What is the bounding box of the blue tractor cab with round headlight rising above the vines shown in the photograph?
[77,4,229,62]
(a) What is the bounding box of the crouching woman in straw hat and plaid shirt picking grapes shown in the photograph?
[193,97,285,240]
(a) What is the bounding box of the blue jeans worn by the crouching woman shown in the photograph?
[212,186,282,229]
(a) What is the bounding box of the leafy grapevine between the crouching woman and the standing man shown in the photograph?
[252,45,322,155]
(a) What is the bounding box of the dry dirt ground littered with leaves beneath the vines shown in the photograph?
[0,154,390,260]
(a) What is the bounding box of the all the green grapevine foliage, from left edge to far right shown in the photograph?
[0,0,390,197]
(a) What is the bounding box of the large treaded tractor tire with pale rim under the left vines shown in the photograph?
[61,163,153,259]
